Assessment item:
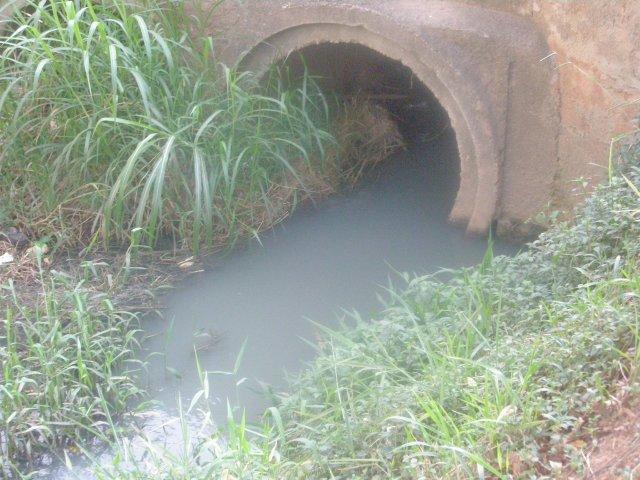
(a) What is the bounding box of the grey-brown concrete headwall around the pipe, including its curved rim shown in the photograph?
[212,0,558,233]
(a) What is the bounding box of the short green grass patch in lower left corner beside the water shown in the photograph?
[0,258,141,472]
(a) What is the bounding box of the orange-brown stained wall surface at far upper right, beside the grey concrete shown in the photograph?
[467,0,640,209]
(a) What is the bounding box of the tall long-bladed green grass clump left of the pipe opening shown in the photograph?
[0,0,333,250]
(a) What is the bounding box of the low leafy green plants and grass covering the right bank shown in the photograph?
[91,141,640,479]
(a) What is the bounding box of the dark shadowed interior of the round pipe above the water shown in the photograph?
[278,43,460,215]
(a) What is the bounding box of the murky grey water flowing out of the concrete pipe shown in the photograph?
[54,130,519,479]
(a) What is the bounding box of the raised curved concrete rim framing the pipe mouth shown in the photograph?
[241,23,500,233]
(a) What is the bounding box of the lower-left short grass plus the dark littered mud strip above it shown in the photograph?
[0,239,200,479]
